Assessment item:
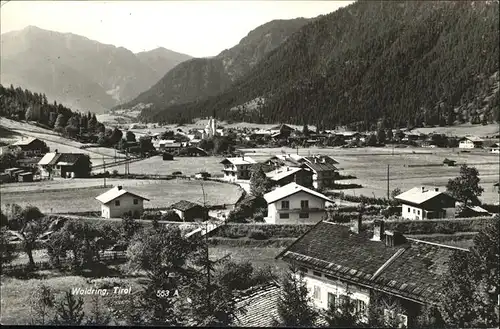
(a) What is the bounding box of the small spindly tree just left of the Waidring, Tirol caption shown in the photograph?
[29,284,55,325]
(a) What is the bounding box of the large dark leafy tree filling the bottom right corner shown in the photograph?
[439,215,500,328]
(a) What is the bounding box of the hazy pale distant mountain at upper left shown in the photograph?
[0,26,190,113]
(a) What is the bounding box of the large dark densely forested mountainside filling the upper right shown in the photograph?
[140,1,499,129]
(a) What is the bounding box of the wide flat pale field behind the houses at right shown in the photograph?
[243,147,500,203]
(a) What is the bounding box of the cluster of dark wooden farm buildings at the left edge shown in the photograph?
[0,137,91,182]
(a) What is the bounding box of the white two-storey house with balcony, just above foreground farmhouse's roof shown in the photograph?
[264,183,334,224]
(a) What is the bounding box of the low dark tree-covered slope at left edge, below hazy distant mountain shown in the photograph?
[0,84,105,141]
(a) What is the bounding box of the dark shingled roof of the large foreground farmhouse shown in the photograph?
[277,222,467,303]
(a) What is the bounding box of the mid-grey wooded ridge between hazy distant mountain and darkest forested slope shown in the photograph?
[115,18,310,109]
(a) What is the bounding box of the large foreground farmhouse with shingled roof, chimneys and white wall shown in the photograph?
[276,220,468,328]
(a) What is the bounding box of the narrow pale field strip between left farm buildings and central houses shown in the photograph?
[95,156,223,176]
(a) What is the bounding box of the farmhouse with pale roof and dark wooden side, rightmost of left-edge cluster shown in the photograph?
[38,150,92,178]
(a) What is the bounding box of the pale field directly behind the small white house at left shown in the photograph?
[1,179,241,213]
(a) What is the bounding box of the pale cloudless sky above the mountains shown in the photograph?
[0,0,354,57]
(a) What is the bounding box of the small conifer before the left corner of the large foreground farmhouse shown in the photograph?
[274,266,319,327]
